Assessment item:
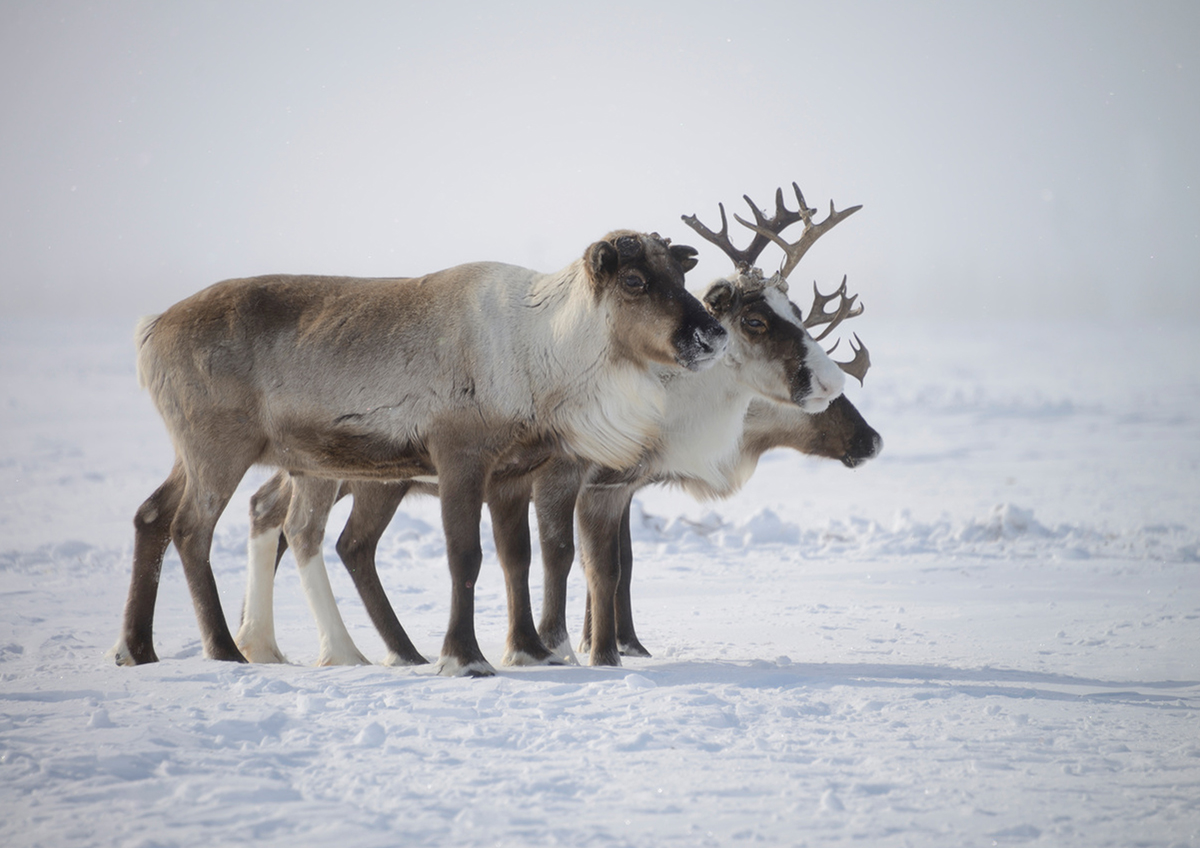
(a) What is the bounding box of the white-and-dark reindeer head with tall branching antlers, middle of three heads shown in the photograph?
[684,184,869,413]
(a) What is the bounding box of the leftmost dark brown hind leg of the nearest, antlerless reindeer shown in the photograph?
[109,459,186,666]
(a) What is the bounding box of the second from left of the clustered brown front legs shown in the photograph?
[487,477,562,666]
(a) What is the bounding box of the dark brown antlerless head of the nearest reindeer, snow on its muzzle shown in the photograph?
[584,230,727,371]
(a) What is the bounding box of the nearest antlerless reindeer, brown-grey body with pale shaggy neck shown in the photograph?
[113,230,727,674]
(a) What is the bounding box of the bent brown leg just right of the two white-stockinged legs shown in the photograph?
[337,481,428,666]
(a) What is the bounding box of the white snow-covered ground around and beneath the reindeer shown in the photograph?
[0,315,1200,848]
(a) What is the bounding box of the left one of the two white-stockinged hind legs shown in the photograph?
[234,471,292,662]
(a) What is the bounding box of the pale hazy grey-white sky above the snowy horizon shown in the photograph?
[0,0,1200,326]
